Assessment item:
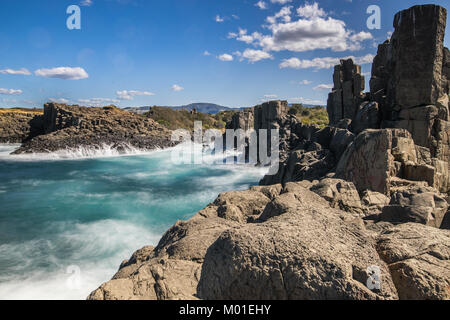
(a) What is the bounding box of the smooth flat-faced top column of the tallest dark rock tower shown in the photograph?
[391,5,448,109]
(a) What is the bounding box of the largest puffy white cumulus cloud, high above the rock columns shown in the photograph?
[229,2,372,52]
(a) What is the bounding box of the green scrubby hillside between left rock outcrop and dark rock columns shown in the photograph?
[144,106,235,130]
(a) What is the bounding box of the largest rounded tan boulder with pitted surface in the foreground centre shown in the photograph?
[198,189,397,300]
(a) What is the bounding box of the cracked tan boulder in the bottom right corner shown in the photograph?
[377,223,450,300]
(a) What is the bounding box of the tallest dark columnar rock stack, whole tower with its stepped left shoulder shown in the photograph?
[370,5,450,172]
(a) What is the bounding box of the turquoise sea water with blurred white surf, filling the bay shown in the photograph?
[0,145,265,299]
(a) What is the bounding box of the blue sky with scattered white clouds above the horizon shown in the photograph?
[0,0,450,108]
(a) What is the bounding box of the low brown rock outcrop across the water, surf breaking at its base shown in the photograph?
[10,103,173,154]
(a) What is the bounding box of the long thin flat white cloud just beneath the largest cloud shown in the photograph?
[280,54,375,70]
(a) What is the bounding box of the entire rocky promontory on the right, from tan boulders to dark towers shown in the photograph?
[89,5,450,300]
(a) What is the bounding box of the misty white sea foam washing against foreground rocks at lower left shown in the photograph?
[0,220,161,300]
